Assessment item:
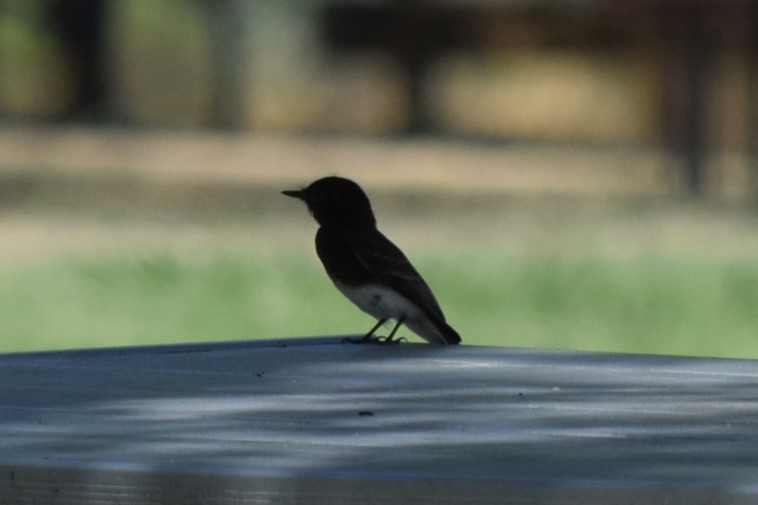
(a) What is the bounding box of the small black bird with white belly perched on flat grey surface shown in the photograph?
[282,177,461,344]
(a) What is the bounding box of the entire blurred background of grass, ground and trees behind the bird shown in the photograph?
[0,0,758,358]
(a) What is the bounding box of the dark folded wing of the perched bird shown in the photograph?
[347,230,445,322]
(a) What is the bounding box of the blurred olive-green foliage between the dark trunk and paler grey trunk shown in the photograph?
[110,0,213,126]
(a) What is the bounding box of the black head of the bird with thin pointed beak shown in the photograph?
[282,177,376,227]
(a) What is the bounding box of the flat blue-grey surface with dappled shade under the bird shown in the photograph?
[0,338,758,505]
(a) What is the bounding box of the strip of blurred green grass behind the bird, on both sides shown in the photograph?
[0,251,758,358]
